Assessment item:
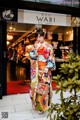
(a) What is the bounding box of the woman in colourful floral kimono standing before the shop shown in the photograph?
[29,28,55,113]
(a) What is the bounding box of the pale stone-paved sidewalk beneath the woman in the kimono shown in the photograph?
[0,91,69,120]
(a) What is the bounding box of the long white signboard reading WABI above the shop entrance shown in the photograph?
[18,10,71,26]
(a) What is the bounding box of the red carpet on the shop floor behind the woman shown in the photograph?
[7,80,56,95]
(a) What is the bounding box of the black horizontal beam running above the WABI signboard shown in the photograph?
[0,0,80,17]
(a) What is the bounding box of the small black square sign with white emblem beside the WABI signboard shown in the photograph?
[0,8,18,22]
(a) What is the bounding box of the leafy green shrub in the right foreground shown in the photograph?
[48,53,80,120]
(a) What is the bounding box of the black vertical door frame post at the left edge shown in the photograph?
[0,21,7,96]
